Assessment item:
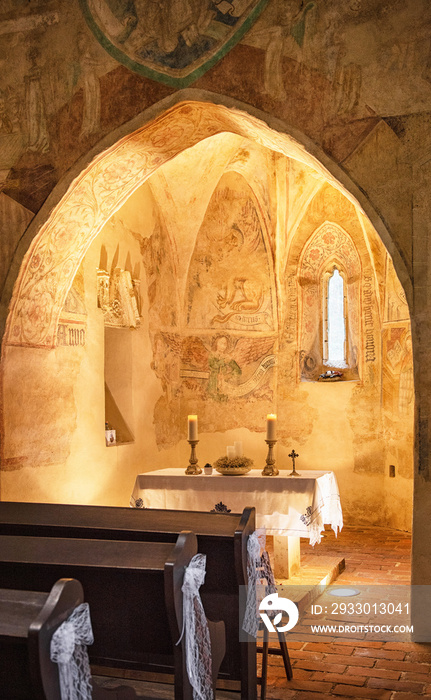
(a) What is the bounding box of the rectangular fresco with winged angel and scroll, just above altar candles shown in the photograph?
[151,332,277,446]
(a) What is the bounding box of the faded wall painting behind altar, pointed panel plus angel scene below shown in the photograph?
[148,167,276,445]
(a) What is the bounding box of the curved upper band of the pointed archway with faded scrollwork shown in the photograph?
[3,90,411,348]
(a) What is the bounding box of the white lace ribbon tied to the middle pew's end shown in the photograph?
[177,554,214,700]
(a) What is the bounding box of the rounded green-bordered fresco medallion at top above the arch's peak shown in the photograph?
[80,0,268,88]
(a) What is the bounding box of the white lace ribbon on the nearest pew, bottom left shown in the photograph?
[51,603,94,700]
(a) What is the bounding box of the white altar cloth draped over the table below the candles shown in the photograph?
[130,468,343,545]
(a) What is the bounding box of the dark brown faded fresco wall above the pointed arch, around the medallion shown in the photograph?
[0,0,431,221]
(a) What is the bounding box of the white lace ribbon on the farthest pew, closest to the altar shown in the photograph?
[242,528,277,637]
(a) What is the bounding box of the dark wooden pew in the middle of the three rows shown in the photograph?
[0,532,226,700]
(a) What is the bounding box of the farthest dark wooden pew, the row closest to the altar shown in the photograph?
[0,501,257,700]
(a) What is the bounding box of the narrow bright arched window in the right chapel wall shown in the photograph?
[323,267,346,367]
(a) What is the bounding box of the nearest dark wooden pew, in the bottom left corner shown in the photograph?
[0,579,137,700]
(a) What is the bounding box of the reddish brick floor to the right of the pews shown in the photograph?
[267,526,431,700]
